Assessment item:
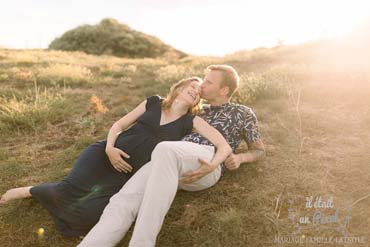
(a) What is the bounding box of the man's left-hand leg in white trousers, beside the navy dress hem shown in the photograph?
[78,162,152,247]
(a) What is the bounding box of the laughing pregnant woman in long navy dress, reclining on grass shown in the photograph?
[0,77,205,236]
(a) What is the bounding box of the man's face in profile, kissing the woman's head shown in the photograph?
[201,70,222,101]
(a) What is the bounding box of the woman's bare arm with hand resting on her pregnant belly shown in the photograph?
[105,100,147,173]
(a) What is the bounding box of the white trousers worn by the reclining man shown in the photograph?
[78,141,221,247]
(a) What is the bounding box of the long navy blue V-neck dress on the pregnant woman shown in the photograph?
[31,96,194,236]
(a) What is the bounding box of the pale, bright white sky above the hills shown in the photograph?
[0,0,370,56]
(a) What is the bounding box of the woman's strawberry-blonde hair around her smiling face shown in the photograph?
[162,76,203,115]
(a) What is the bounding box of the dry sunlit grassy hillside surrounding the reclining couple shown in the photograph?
[0,37,370,247]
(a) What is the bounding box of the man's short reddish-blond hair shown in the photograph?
[206,64,240,98]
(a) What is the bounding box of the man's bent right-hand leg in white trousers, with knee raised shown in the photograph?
[130,141,221,246]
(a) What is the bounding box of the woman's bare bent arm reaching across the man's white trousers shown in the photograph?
[180,116,232,183]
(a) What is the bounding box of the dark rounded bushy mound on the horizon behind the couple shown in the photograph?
[49,19,186,58]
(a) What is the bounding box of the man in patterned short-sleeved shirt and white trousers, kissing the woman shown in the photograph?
[79,65,265,247]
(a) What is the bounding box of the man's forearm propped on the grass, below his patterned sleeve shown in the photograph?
[225,139,265,170]
